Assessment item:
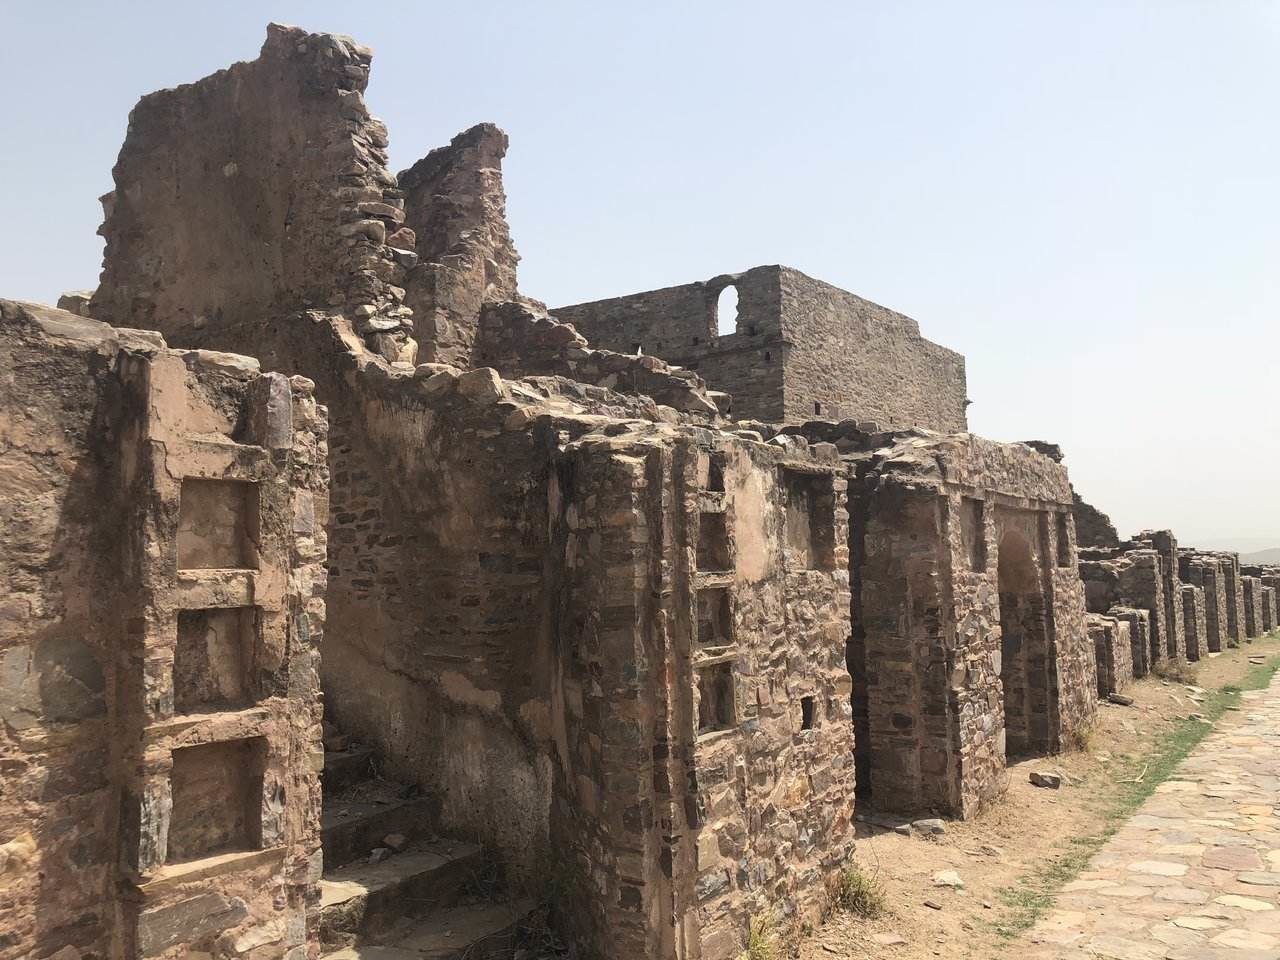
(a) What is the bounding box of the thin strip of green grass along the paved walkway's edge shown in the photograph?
[993,647,1280,940]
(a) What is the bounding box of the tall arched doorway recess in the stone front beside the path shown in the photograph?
[997,529,1056,758]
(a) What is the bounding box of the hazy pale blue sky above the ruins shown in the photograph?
[0,0,1280,549]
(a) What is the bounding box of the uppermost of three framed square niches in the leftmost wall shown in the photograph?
[178,477,259,570]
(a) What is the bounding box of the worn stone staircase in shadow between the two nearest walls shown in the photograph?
[311,735,532,960]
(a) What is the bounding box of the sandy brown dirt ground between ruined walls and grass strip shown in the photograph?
[800,634,1280,960]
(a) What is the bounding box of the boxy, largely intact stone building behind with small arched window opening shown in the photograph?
[552,266,968,431]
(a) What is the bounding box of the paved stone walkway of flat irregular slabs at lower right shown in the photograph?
[1024,675,1280,960]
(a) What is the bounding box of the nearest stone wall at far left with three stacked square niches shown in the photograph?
[0,301,326,960]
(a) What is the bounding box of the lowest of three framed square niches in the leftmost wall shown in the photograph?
[166,737,266,863]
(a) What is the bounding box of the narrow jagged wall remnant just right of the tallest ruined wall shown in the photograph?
[393,123,520,366]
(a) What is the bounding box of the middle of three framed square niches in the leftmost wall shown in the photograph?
[173,607,257,713]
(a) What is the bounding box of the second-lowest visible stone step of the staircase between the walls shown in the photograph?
[315,841,483,948]
